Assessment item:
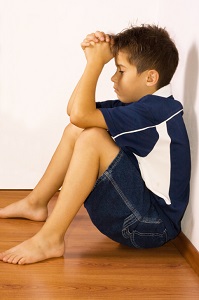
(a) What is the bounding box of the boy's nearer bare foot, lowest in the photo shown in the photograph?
[0,234,64,265]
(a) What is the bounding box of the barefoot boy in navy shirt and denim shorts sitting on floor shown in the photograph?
[0,25,190,264]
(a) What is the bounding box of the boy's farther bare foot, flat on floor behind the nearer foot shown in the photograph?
[0,197,48,221]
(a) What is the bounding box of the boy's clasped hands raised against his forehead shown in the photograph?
[81,31,113,65]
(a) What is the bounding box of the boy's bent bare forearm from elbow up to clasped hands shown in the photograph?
[67,33,113,129]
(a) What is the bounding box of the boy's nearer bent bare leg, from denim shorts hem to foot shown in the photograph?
[0,128,119,264]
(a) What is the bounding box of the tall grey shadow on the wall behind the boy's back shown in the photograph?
[183,44,199,236]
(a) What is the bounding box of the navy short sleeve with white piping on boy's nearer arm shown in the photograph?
[100,102,158,156]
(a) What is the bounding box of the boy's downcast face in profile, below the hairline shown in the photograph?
[111,51,151,103]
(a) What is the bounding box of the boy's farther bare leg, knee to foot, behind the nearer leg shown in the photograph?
[0,124,83,221]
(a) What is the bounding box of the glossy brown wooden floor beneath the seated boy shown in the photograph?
[0,191,199,300]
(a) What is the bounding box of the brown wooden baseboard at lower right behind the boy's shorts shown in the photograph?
[173,232,199,276]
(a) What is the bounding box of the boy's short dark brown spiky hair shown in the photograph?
[112,24,179,88]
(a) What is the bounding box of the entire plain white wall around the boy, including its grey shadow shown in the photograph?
[0,0,199,250]
